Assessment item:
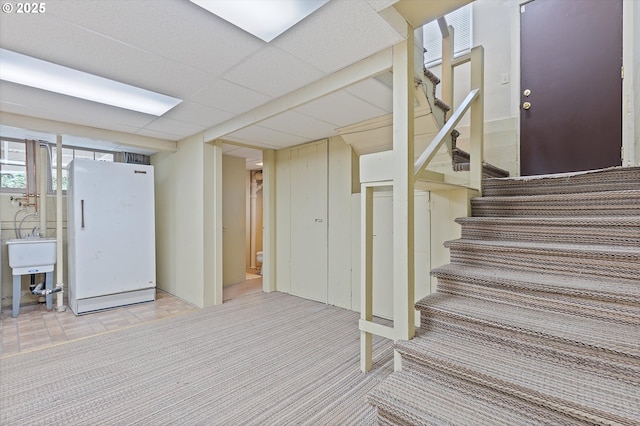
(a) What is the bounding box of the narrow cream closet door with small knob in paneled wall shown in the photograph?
[291,141,328,303]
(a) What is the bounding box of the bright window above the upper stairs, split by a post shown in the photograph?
[423,3,472,67]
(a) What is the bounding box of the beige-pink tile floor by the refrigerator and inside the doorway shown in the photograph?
[0,277,262,357]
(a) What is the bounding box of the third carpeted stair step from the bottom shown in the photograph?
[416,293,640,363]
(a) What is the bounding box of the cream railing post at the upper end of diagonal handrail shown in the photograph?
[469,46,484,193]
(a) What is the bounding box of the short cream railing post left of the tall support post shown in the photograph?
[360,184,373,373]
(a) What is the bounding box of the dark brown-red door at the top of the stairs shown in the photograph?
[520,0,622,176]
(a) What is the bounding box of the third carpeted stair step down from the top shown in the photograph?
[456,216,640,246]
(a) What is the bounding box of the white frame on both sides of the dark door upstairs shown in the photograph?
[511,0,640,173]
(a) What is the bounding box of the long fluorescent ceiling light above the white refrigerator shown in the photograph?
[0,49,182,116]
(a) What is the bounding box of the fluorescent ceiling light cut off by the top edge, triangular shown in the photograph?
[191,0,329,43]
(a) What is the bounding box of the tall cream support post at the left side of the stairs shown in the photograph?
[393,24,415,371]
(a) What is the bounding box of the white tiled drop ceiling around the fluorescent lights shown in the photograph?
[0,0,470,160]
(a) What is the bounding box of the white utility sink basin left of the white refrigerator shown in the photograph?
[7,238,56,269]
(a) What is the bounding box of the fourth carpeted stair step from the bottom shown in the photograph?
[434,267,640,326]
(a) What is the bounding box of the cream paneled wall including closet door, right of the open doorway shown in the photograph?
[276,138,353,308]
